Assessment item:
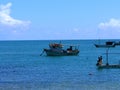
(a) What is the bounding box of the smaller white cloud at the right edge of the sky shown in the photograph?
[98,18,120,29]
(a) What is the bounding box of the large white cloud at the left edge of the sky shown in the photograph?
[0,3,30,29]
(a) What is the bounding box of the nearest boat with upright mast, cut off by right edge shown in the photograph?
[96,48,120,69]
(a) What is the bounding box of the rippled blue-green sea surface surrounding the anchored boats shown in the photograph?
[0,40,120,90]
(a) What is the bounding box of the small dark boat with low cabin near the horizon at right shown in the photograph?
[94,41,116,48]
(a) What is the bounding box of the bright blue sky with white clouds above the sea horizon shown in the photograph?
[0,0,120,40]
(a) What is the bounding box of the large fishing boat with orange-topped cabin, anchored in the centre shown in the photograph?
[44,43,79,56]
